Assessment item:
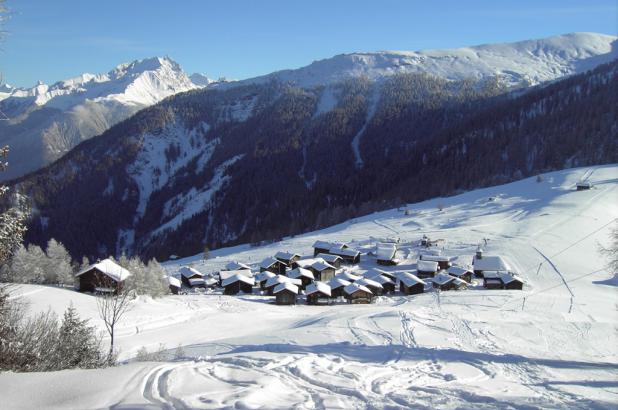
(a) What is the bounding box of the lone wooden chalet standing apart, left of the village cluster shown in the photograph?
[75,259,131,293]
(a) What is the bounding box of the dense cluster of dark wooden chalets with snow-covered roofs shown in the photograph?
[161,237,524,305]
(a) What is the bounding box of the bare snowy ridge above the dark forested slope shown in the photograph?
[246,33,618,87]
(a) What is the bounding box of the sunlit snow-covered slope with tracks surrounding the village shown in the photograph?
[0,165,618,409]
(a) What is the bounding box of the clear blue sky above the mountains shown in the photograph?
[0,0,618,86]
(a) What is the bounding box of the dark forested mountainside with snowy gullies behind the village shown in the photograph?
[12,61,618,258]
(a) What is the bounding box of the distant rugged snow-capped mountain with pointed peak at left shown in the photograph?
[0,57,205,179]
